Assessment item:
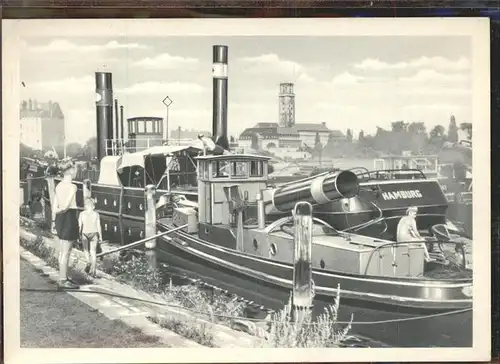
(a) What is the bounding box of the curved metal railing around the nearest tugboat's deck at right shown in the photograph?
[364,236,468,275]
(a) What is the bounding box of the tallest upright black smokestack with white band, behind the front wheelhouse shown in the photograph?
[212,45,229,150]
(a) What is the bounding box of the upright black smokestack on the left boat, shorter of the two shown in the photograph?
[95,72,113,160]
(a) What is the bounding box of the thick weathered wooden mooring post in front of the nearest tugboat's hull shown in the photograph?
[292,202,313,322]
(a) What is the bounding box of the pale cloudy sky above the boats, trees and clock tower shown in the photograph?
[20,35,473,143]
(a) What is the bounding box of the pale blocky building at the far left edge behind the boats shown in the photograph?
[19,99,65,155]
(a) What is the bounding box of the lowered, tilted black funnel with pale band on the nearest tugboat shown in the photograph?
[263,171,359,214]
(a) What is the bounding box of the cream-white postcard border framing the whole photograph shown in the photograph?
[2,18,491,363]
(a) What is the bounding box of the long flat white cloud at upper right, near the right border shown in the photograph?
[354,57,470,71]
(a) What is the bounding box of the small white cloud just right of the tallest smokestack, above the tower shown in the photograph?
[236,53,305,77]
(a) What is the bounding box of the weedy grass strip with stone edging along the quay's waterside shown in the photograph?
[20,217,359,348]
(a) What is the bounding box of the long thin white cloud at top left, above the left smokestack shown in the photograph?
[26,39,148,53]
